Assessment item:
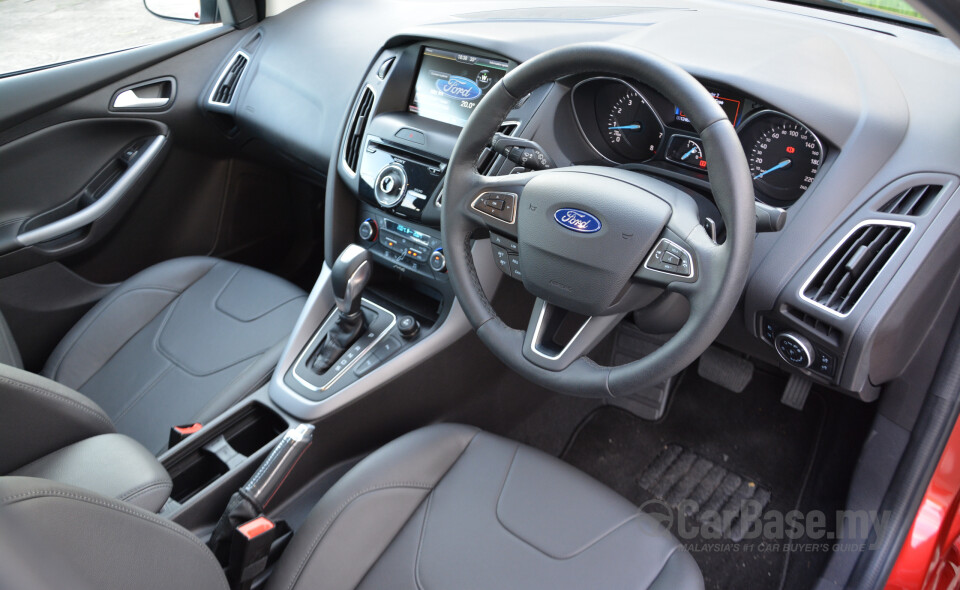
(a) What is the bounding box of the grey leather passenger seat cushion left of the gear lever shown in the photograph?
[43,257,306,453]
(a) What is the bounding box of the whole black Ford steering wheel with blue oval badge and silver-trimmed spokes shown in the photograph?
[442,43,756,397]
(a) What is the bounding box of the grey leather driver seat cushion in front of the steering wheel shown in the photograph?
[269,425,703,590]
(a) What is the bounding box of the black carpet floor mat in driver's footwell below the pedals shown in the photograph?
[562,371,868,590]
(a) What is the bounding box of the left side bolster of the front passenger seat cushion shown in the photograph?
[42,256,219,389]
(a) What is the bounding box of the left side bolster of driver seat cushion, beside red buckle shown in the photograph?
[269,424,479,590]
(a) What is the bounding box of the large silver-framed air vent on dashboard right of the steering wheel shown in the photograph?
[801,220,913,317]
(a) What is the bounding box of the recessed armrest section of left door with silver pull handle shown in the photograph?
[0,119,168,266]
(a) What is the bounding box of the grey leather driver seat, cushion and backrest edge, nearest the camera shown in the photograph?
[0,424,703,590]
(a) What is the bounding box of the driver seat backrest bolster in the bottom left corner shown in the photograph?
[0,476,228,590]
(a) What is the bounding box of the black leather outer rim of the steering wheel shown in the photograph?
[442,43,755,397]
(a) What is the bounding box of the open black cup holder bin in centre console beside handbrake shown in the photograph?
[164,402,287,504]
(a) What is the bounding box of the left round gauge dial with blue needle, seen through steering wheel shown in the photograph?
[597,84,663,161]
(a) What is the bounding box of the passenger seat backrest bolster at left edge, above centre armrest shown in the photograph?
[0,365,115,474]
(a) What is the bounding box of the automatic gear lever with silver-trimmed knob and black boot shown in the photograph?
[311,244,373,374]
